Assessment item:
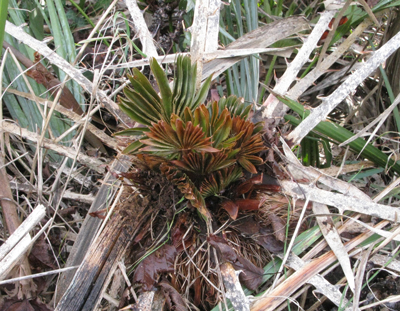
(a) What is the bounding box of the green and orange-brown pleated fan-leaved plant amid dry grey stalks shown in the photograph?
[116,56,265,217]
